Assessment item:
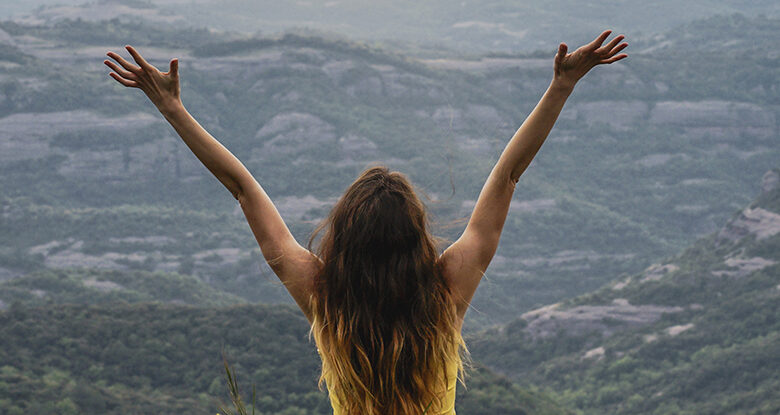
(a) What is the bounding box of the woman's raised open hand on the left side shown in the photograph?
[103,45,181,113]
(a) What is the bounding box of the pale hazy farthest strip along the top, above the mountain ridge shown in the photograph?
[0,0,780,52]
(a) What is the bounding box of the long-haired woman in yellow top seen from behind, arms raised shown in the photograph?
[105,31,628,415]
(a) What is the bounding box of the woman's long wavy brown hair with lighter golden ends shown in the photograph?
[309,166,469,415]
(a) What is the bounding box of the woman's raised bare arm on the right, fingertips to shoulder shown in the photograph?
[440,30,628,313]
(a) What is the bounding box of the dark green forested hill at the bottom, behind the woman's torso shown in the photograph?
[0,303,570,415]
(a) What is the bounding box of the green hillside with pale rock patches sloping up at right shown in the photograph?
[473,169,780,414]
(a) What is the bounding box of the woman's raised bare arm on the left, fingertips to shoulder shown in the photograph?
[104,46,318,317]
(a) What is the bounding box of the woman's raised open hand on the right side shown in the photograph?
[553,30,628,88]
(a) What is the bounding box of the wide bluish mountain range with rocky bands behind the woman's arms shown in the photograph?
[0,5,780,327]
